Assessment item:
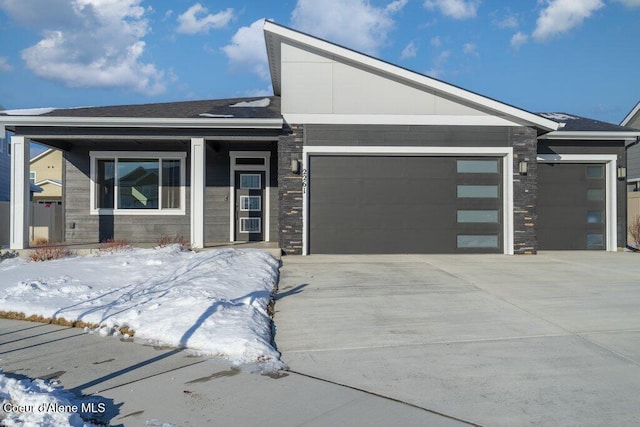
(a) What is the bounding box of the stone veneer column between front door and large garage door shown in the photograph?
[278,125,304,255]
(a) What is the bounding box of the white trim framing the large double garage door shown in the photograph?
[302,146,514,255]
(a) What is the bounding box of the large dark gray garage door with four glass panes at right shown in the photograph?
[308,156,503,254]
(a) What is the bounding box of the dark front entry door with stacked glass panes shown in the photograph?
[235,171,265,242]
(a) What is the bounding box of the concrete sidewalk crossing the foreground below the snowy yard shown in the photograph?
[0,320,468,426]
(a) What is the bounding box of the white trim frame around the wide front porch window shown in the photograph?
[89,151,187,216]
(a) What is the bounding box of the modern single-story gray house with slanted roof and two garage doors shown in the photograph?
[0,22,640,254]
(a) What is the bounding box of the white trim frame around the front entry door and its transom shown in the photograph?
[229,151,271,242]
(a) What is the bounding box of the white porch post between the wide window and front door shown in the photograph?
[191,138,206,248]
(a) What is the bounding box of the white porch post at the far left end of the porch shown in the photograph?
[9,136,31,249]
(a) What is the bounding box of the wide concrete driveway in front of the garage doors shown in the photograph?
[275,252,640,426]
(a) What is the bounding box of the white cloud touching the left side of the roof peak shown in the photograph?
[222,19,270,80]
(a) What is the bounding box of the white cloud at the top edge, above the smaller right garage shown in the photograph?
[533,0,604,42]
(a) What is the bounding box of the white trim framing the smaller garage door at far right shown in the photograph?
[537,154,618,252]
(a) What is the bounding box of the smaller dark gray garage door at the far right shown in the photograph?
[538,163,607,250]
